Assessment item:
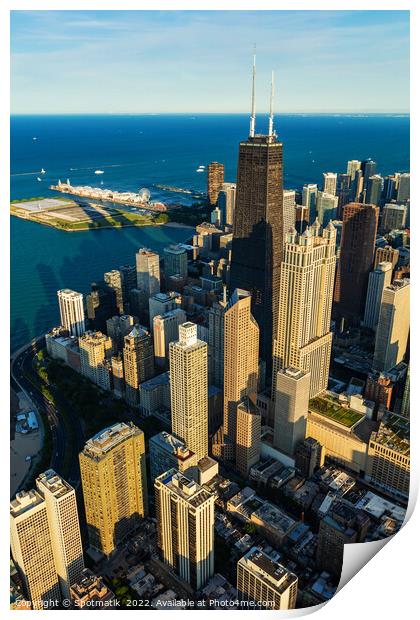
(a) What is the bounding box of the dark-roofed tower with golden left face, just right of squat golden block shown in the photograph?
[123,325,155,407]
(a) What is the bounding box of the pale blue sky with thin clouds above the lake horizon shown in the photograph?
[11,10,409,114]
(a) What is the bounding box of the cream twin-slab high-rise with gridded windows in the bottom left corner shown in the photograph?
[10,469,84,609]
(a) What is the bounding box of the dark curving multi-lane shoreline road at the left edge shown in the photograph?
[10,336,84,488]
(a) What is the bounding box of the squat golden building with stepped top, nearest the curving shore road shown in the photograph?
[79,331,112,390]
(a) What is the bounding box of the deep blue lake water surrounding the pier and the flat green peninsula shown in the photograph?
[11,115,409,348]
